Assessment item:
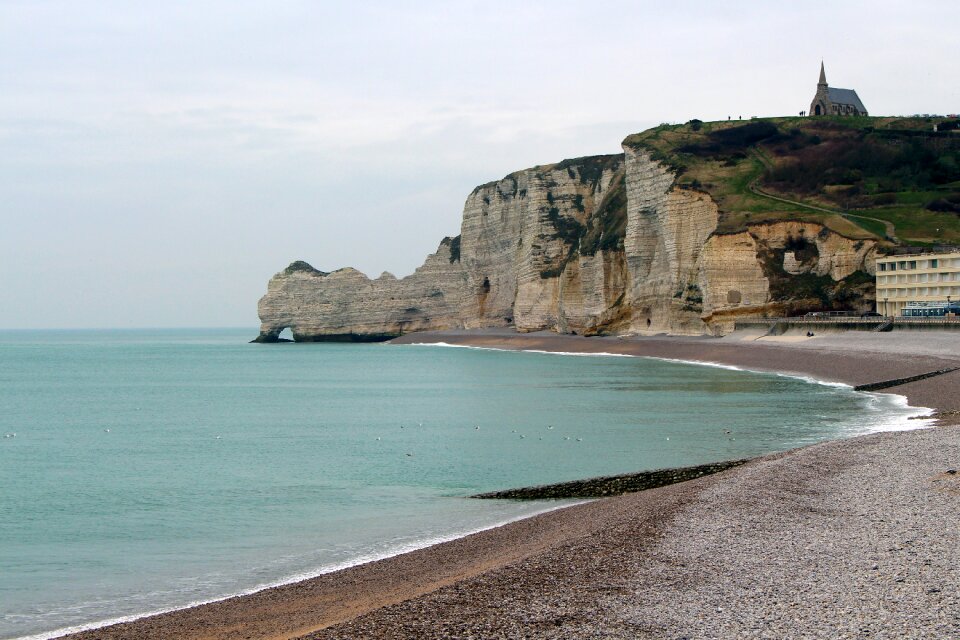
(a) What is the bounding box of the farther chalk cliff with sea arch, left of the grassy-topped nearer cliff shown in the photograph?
[257,155,628,342]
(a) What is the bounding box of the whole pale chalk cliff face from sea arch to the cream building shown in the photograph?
[258,147,876,342]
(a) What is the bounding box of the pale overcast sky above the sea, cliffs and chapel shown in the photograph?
[0,0,960,328]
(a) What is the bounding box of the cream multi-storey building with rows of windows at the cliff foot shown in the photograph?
[877,253,960,316]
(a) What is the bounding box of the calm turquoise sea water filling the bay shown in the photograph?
[0,330,918,638]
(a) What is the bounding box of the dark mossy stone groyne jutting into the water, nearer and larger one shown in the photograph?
[470,458,750,500]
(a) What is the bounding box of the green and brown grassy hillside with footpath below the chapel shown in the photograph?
[623,116,960,245]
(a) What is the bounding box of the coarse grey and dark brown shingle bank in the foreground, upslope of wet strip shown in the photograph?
[309,427,960,640]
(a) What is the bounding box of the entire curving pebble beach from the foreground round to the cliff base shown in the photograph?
[62,331,960,639]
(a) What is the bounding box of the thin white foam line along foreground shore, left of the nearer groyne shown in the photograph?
[11,500,591,640]
